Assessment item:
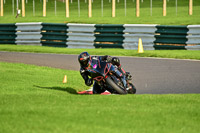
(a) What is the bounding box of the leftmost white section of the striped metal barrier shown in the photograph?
[16,23,42,45]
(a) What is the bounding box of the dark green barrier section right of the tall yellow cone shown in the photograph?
[154,25,188,49]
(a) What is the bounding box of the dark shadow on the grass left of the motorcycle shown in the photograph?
[34,85,78,94]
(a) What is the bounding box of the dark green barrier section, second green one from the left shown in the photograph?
[41,23,68,47]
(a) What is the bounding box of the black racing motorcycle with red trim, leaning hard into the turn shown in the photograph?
[87,57,136,94]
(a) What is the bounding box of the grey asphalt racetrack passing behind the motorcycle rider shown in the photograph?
[0,52,200,94]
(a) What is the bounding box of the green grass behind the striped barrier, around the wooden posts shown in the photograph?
[0,0,200,25]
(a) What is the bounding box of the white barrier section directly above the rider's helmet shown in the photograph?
[66,23,95,48]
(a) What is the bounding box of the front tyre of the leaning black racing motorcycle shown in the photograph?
[106,77,127,94]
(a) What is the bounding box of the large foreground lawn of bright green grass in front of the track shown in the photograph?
[0,62,200,133]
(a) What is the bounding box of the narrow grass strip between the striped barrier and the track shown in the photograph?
[0,45,200,60]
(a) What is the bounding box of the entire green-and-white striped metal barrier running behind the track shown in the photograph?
[0,23,200,50]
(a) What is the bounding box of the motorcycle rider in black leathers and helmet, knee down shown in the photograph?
[78,52,131,94]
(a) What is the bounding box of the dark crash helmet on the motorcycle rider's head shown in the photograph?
[78,52,91,67]
